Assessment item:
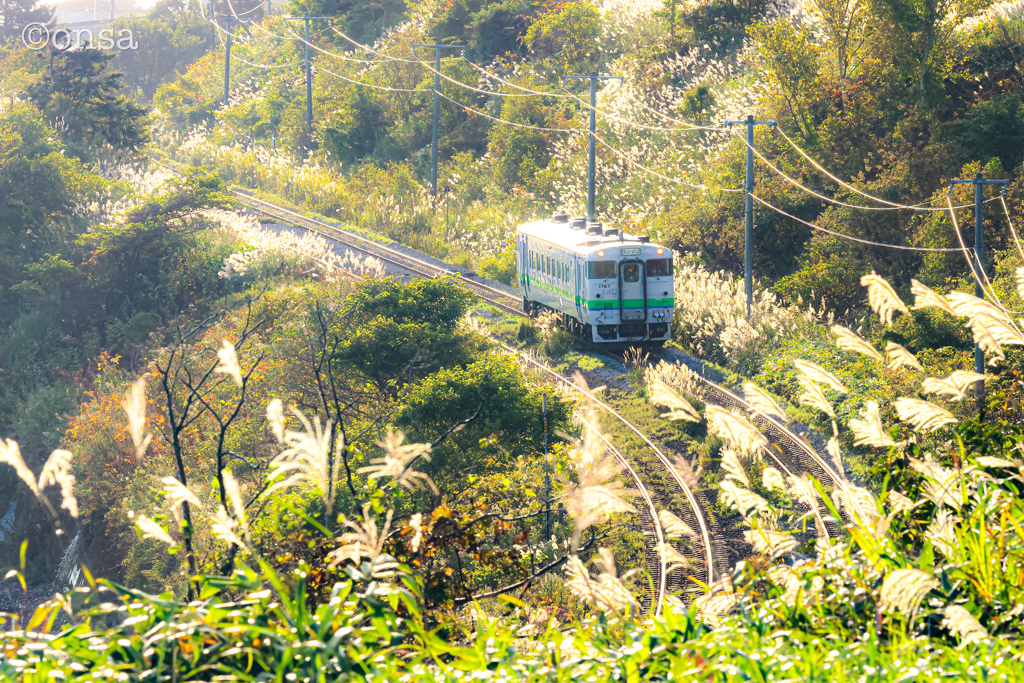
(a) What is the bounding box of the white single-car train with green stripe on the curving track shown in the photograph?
[516,214,675,343]
